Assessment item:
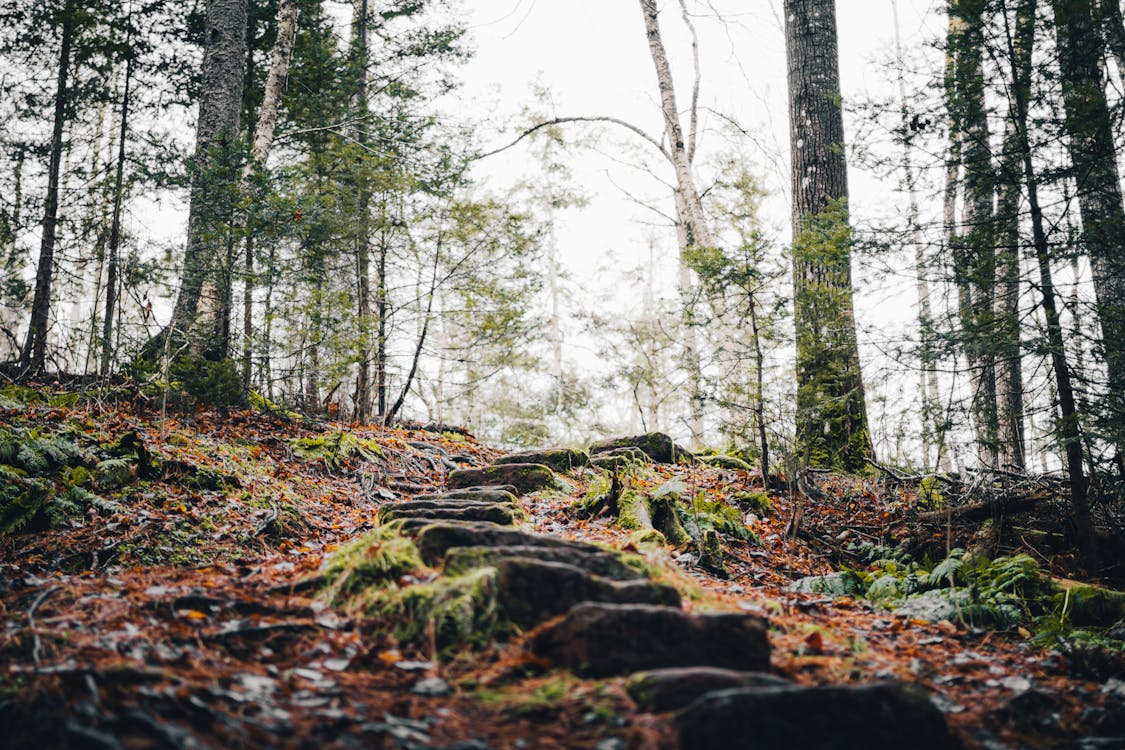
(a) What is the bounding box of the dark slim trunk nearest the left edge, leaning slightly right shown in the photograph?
[20,0,74,374]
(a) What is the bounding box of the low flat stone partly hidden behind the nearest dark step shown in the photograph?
[626,667,793,714]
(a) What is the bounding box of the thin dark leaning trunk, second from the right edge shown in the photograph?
[1001,0,1098,575]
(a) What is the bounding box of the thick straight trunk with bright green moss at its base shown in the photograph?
[784,0,872,470]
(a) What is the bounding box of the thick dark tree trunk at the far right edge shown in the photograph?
[1051,0,1125,452]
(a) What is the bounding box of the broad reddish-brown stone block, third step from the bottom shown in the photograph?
[531,604,770,677]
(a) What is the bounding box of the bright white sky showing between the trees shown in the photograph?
[443,0,944,454]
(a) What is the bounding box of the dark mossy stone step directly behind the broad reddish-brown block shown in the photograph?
[496,558,681,629]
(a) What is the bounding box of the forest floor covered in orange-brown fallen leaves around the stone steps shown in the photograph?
[0,397,1125,750]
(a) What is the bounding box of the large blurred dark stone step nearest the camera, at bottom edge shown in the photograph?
[674,683,954,750]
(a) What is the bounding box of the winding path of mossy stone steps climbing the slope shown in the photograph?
[346,441,953,750]
